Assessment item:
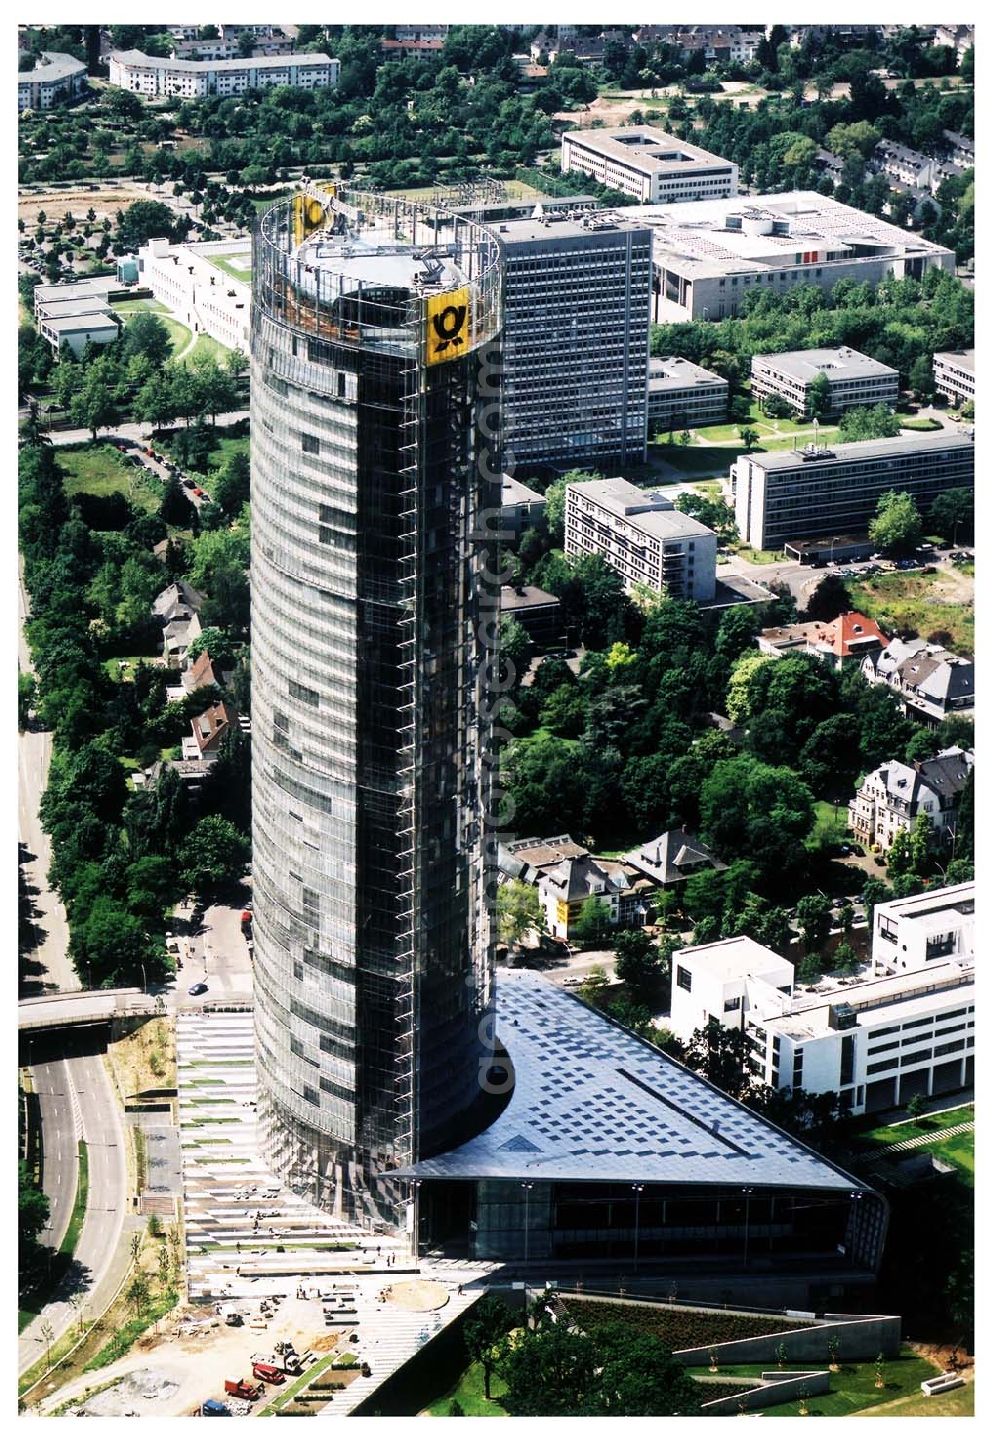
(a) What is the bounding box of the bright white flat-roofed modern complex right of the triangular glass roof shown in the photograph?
[669,884,976,1114]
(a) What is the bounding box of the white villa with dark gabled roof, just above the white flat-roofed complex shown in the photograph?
[847,745,976,853]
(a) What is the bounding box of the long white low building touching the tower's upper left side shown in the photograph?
[135,240,250,354]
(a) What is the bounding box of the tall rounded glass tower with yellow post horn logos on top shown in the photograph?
[250,186,501,1222]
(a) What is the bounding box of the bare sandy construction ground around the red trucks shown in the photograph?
[39,1298,350,1419]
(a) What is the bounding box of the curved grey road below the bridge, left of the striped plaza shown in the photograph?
[17,1040,129,1373]
